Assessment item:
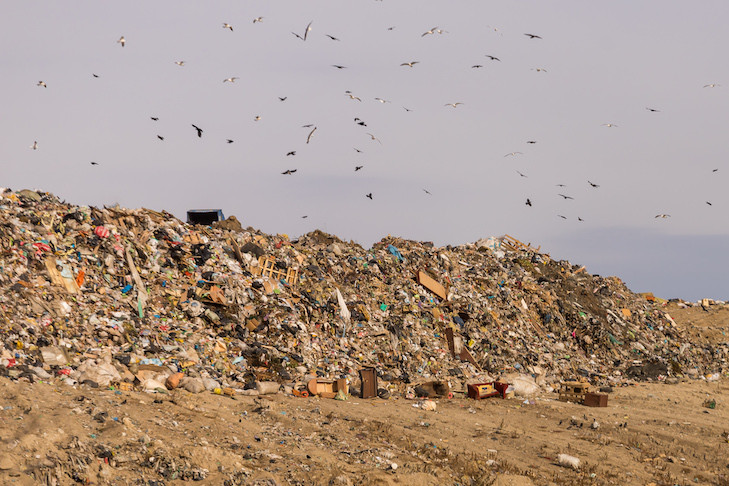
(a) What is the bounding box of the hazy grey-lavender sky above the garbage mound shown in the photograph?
[0,0,729,300]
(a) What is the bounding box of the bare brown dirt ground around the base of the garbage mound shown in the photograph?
[0,307,729,486]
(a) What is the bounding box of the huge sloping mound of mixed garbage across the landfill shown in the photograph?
[0,190,729,396]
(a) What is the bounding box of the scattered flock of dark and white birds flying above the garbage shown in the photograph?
[30,12,721,226]
